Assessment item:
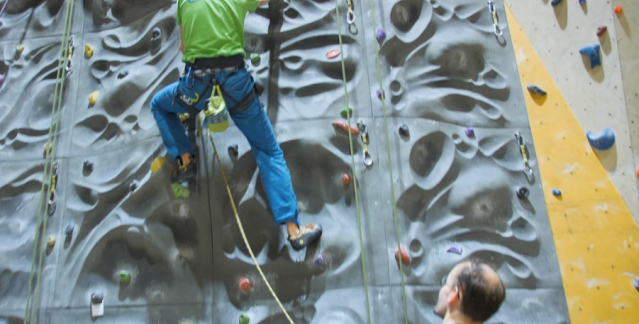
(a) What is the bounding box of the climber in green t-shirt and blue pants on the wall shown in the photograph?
[151,0,322,250]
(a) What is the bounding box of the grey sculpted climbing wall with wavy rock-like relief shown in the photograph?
[0,0,569,324]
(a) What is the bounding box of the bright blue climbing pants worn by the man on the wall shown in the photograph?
[151,68,299,225]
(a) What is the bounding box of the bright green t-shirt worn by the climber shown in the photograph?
[177,0,258,62]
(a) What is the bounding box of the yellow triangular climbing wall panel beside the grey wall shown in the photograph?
[506,8,639,324]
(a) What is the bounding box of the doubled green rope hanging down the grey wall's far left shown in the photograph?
[24,0,74,324]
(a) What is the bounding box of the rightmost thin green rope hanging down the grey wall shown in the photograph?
[370,0,408,324]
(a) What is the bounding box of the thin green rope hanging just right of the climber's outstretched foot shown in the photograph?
[335,0,371,324]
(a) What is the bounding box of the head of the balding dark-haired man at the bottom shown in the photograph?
[433,260,506,324]
